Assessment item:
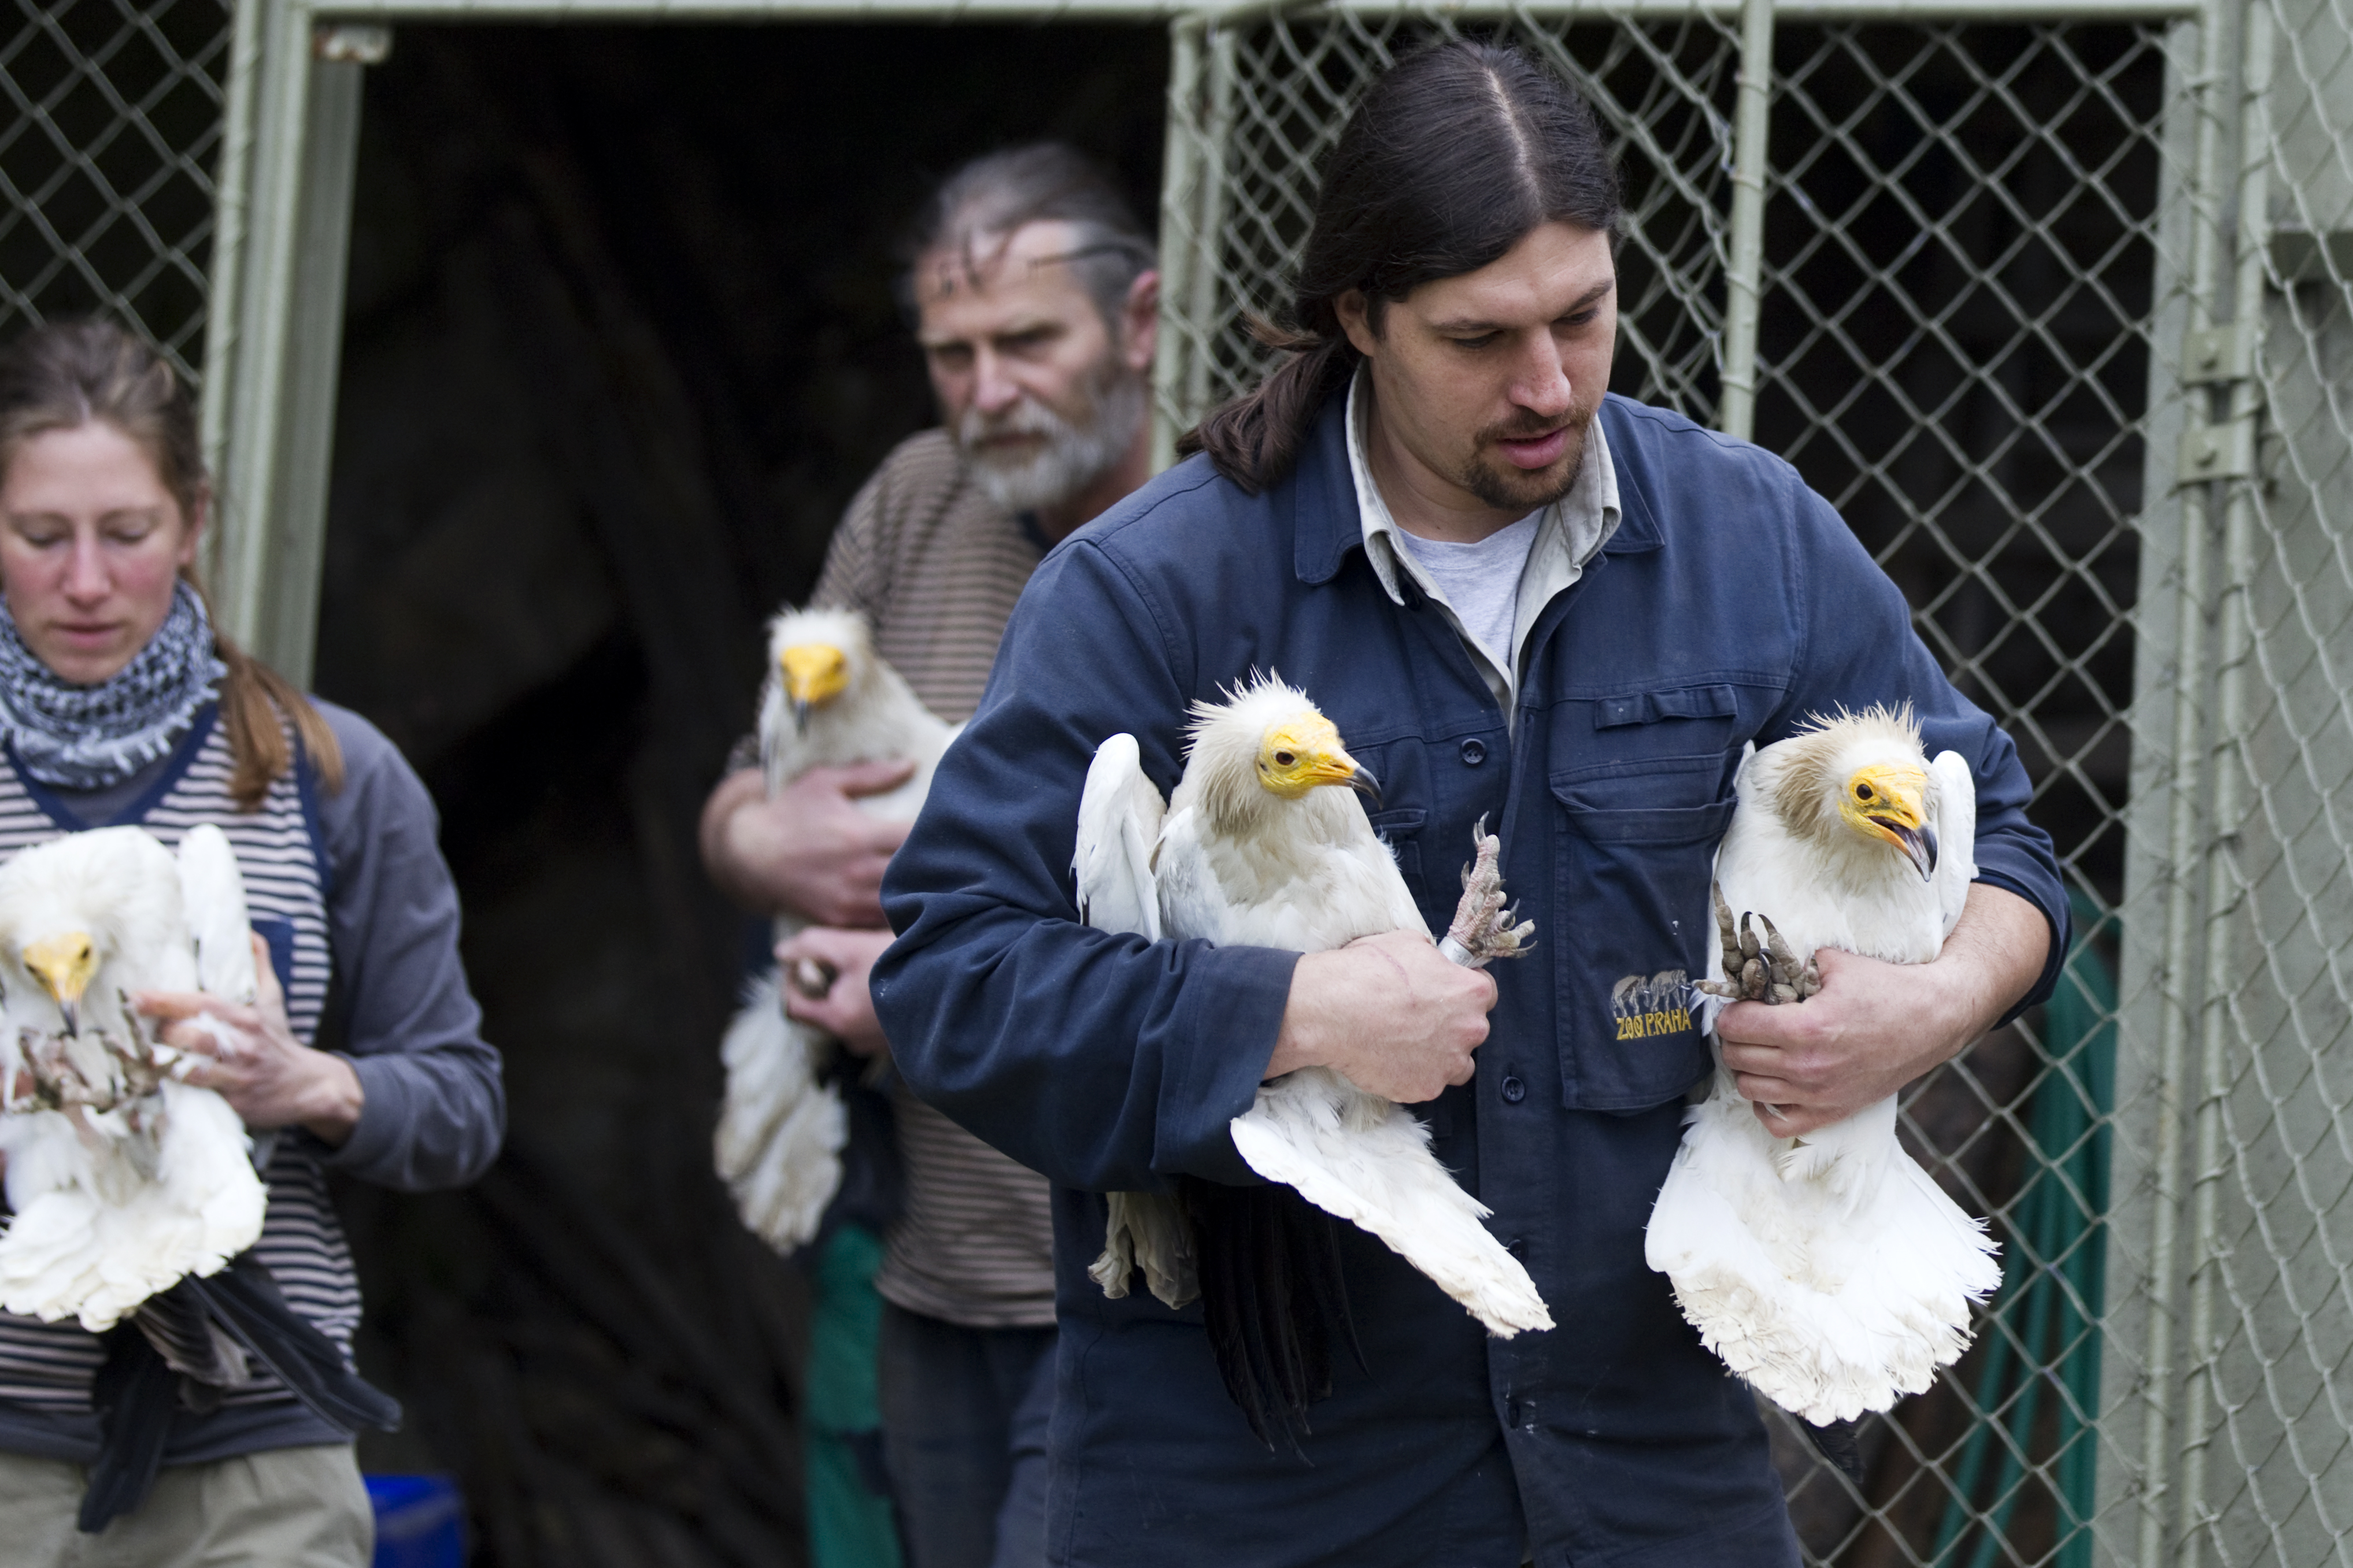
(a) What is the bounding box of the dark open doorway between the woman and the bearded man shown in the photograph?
[304,26,1167,1568]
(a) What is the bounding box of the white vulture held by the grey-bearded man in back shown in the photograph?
[713,609,955,1253]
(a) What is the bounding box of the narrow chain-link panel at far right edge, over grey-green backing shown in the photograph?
[2184,0,2353,1566]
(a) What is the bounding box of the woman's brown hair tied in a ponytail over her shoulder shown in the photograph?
[0,322,343,811]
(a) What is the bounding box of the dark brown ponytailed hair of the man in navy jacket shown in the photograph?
[1176,38,1619,494]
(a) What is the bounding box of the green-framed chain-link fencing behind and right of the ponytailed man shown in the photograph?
[1160,0,2353,1568]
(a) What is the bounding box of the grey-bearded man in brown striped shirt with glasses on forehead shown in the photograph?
[704,146,1157,1568]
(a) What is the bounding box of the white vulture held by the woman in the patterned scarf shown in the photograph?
[0,825,266,1333]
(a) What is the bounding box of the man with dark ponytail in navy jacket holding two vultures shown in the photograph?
[873,42,2066,1568]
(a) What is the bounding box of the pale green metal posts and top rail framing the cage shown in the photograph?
[188,0,2353,1568]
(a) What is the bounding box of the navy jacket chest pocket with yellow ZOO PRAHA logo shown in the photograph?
[1553,757,1734,1110]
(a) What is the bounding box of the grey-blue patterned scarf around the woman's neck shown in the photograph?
[0,583,228,790]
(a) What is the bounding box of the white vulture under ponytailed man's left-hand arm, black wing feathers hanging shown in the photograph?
[1071,677,1553,1439]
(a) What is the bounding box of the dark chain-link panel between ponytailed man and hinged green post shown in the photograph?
[1755,24,2181,1568]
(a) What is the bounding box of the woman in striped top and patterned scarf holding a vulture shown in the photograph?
[0,322,506,1568]
